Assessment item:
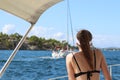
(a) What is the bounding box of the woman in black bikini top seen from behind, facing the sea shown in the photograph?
[66,30,111,80]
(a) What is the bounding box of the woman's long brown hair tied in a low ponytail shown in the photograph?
[77,30,93,69]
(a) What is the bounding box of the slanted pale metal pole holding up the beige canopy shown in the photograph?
[0,24,34,77]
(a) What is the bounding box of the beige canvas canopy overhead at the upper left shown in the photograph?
[0,0,61,24]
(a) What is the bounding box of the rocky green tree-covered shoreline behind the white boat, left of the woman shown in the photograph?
[0,32,72,50]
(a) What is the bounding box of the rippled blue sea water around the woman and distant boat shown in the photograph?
[0,50,120,80]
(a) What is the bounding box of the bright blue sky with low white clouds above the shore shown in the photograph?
[0,0,120,48]
